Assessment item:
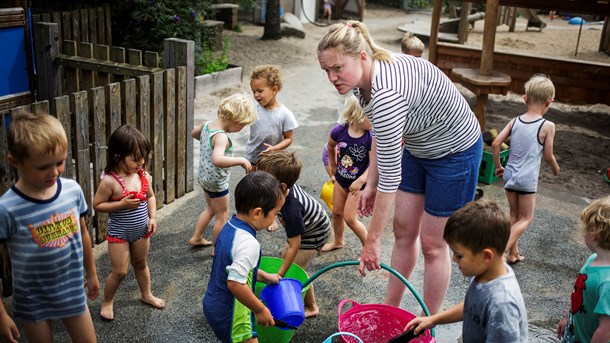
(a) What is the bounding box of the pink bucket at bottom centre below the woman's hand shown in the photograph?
[338,299,436,343]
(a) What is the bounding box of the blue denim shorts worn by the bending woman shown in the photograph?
[398,138,483,217]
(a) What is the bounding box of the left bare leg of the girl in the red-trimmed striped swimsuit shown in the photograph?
[100,243,129,320]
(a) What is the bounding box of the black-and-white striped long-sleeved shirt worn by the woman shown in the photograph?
[354,54,481,193]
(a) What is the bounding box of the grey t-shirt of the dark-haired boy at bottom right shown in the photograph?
[462,265,527,343]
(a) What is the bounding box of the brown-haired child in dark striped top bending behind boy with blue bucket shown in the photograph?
[257,150,330,318]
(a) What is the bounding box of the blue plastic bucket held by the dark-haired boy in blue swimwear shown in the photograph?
[261,278,305,330]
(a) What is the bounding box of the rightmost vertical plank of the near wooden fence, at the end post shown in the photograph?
[175,67,185,198]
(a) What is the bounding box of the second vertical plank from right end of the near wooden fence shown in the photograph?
[163,69,176,204]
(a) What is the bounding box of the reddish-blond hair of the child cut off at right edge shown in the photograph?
[580,196,610,250]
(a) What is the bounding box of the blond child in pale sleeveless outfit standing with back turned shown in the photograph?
[491,74,559,264]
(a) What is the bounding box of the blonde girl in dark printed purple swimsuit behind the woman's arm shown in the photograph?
[322,96,373,252]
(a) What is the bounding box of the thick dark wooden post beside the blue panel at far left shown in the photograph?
[34,23,61,100]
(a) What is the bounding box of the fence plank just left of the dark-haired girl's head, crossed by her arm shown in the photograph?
[90,87,109,244]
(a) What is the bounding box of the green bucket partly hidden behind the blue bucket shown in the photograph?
[254,256,309,343]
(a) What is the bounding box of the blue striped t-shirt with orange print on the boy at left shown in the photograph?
[0,178,89,322]
